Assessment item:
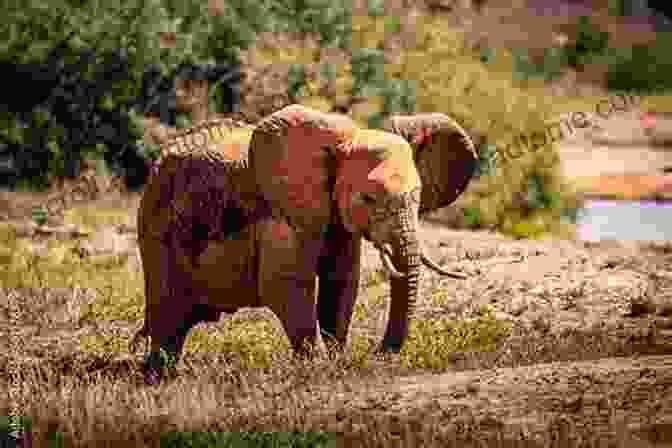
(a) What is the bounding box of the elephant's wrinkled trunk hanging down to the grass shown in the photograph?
[380,210,422,353]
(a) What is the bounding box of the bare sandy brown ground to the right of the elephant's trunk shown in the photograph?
[1,188,672,447]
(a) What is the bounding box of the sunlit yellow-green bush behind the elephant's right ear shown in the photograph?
[362,11,576,238]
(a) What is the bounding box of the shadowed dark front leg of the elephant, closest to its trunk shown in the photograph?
[317,224,361,350]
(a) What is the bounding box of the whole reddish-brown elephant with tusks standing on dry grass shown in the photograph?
[131,104,478,383]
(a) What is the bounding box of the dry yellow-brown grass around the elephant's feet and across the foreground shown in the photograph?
[0,204,669,447]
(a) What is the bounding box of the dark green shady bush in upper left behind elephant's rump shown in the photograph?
[0,0,249,188]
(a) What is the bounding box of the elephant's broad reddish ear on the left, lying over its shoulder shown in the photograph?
[249,104,356,231]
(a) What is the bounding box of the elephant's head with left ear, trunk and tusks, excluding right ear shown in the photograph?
[250,105,468,352]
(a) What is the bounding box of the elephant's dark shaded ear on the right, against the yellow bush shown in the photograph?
[384,113,478,215]
